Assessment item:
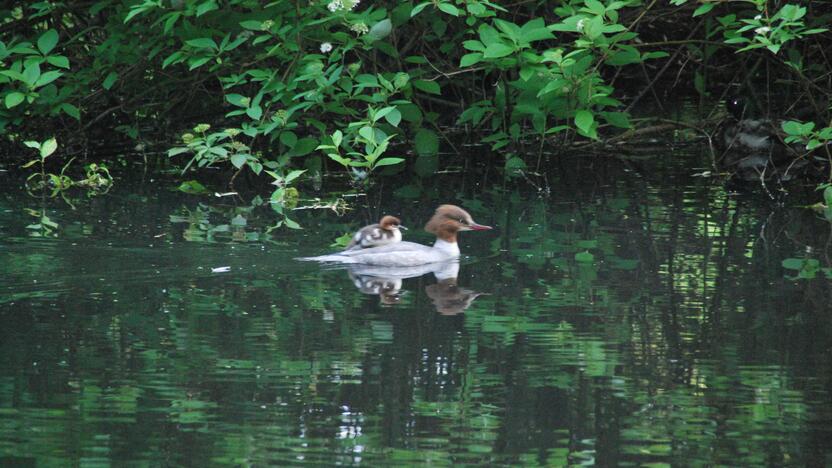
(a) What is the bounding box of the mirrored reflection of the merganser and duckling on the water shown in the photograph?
[347,260,483,315]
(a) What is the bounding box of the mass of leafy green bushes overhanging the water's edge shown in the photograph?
[0,0,828,208]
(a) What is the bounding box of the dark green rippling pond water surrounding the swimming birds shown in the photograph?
[0,155,832,466]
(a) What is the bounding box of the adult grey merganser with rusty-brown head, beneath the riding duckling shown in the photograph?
[299,205,491,267]
